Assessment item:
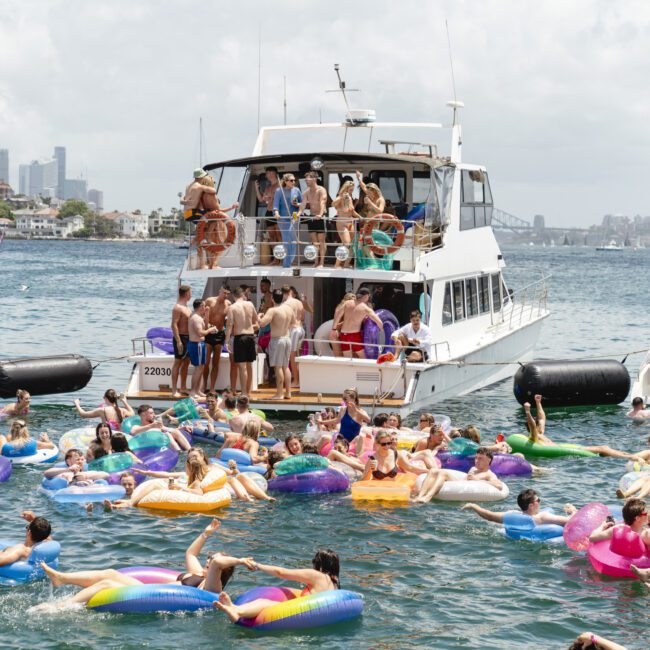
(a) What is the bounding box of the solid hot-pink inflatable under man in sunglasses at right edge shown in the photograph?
[587,525,650,578]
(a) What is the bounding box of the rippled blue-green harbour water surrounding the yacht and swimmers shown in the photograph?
[0,241,650,650]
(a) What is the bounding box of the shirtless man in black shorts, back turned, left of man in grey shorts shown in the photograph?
[226,287,258,395]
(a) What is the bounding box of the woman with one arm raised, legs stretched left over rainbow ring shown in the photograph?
[41,519,253,608]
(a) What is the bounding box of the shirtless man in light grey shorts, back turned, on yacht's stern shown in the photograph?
[260,289,295,399]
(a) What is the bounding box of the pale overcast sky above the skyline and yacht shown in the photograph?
[0,0,650,226]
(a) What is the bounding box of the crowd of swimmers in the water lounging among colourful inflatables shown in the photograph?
[0,388,650,648]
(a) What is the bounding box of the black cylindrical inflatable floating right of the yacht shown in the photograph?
[513,359,630,407]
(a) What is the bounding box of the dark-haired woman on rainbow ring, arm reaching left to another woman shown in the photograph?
[214,549,341,623]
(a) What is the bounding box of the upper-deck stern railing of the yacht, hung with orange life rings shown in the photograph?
[188,214,442,271]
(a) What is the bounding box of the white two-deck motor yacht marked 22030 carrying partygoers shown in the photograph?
[126,102,549,415]
